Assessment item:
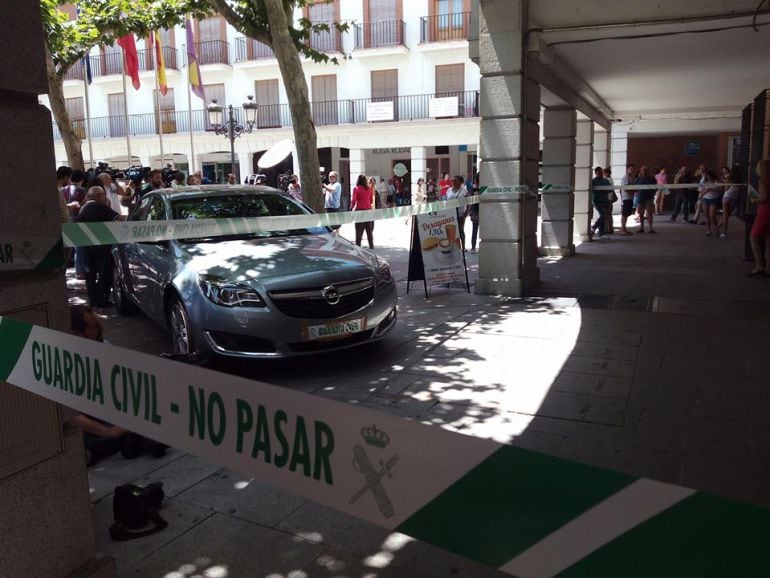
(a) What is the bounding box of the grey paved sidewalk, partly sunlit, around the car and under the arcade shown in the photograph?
[68,216,770,578]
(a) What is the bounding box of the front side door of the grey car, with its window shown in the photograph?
[126,194,173,321]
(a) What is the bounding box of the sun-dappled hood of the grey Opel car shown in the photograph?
[179,234,376,283]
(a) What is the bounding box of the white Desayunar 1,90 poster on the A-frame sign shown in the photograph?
[415,209,465,285]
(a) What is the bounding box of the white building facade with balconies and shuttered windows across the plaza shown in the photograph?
[43,0,480,202]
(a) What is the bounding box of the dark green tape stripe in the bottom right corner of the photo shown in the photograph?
[558,494,770,578]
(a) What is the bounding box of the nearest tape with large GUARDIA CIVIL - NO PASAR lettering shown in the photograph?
[0,317,770,578]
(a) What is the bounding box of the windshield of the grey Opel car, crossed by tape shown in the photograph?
[171,193,328,243]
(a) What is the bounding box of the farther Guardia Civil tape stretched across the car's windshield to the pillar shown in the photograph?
[62,192,498,247]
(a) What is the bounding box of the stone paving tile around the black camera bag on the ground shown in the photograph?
[93,498,212,575]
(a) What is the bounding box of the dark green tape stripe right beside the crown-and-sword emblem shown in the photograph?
[397,446,635,567]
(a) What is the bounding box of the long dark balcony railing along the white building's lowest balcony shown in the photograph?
[49,91,479,139]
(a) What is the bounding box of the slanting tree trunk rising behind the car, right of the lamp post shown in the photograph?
[265,0,324,212]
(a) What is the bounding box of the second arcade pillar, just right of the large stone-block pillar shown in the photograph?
[540,107,577,257]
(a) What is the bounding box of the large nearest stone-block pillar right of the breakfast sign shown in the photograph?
[476,0,540,296]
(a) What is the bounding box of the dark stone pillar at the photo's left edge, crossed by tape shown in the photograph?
[0,2,115,578]
